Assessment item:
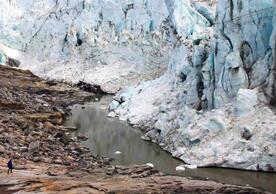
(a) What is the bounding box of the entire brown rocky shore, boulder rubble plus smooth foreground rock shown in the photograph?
[0,66,270,193]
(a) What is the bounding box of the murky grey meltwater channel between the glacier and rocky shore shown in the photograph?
[66,96,276,193]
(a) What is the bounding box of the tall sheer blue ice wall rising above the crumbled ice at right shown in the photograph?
[214,0,274,107]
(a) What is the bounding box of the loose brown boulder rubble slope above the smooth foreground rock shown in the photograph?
[0,66,108,167]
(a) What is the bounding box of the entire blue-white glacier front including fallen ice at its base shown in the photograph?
[0,0,276,171]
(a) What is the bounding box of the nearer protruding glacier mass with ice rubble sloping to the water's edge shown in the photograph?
[110,0,276,171]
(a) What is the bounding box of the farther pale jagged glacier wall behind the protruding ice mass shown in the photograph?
[0,0,210,93]
